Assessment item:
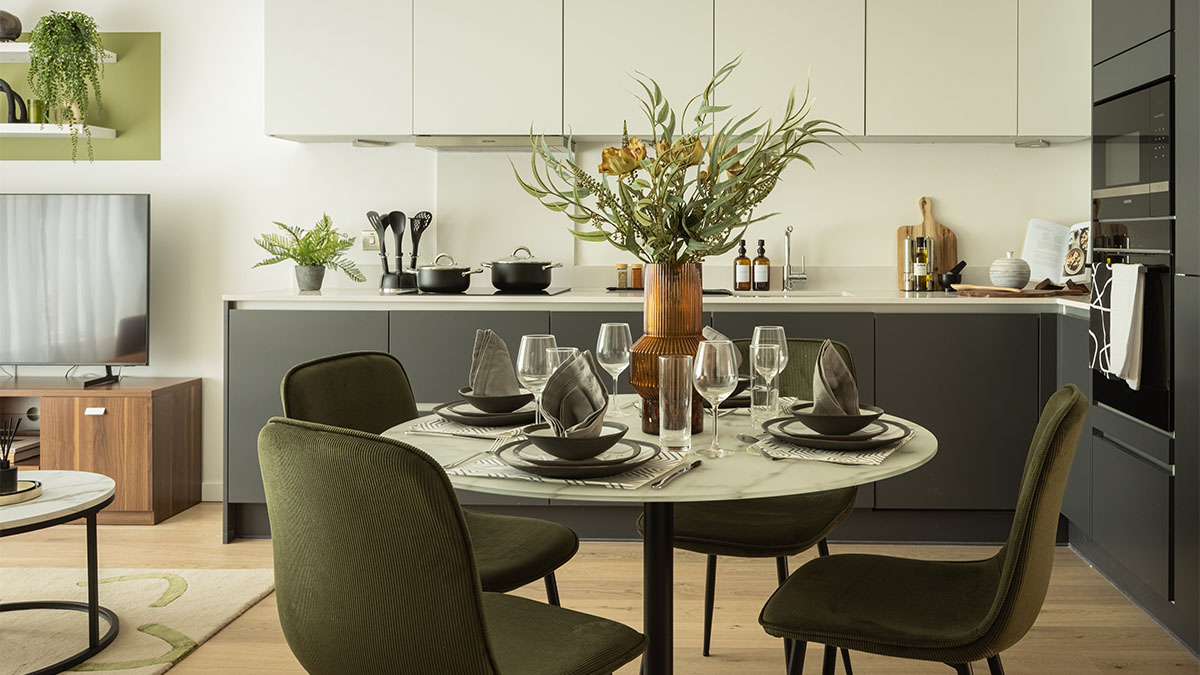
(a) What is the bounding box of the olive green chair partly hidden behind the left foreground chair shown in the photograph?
[280,352,580,604]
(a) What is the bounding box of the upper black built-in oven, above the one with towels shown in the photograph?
[1092,80,1175,219]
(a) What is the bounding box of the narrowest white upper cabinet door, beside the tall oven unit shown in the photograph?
[1016,0,1092,137]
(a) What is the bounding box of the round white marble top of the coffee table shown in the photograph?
[0,471,116,532]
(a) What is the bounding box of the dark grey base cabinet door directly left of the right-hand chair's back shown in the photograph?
[875,313,1052,510]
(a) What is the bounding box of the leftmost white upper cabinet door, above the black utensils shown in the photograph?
[264,0,413,141]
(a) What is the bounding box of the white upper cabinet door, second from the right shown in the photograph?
[866,0,1017,136]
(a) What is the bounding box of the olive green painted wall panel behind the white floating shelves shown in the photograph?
[0,32,162,161]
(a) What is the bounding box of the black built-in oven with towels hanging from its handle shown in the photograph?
[1090,216,1175,431]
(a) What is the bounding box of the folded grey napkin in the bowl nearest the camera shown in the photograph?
[541,352,608,438]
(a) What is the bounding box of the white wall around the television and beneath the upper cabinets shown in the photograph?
[0,0,1088,500]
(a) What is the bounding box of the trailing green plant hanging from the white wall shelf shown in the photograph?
[29,12,104,161]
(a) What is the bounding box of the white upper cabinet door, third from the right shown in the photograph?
[716,0,875,136]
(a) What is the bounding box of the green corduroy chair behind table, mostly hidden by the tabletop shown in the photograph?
[637,338,858,673]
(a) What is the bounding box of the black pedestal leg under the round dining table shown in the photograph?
[642,502,674,675]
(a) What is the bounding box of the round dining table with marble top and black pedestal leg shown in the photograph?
[383,394,937,675]
